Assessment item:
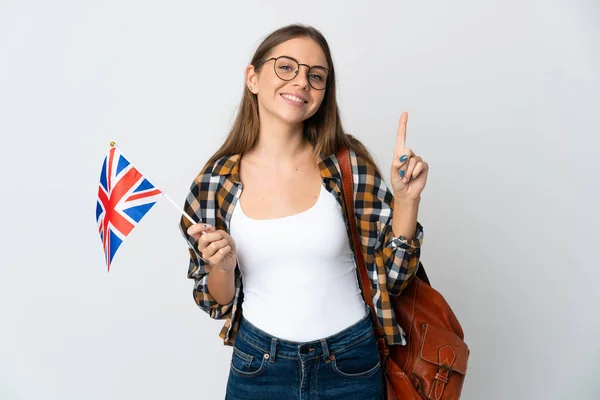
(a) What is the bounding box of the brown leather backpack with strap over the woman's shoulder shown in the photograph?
[337,148,469,400]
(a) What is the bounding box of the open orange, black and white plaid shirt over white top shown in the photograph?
[180,151,423,346]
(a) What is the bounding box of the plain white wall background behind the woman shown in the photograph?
[0,0,600,400]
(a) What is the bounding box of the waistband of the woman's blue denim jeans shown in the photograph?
[237,306,374,362]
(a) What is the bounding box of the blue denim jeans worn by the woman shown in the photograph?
[225,310,384,400]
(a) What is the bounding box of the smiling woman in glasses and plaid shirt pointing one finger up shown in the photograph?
[181,25,429,400]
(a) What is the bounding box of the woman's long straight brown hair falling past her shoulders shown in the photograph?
[207,24,379,177]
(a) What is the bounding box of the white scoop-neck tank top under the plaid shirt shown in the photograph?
[230,185,367,342]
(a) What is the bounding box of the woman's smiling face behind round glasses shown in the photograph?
[246,37,329,125]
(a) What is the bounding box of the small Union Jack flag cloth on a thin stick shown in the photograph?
[96,147,162,271]
